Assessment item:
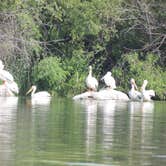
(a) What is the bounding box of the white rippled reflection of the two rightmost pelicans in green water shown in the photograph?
[128,102,155,163]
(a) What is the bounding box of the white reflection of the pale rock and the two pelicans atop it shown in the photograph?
[77,99,127,157]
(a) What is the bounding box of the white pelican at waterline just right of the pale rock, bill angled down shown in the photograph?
[128,78,142,101]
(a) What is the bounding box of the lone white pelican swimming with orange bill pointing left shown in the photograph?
[26,85,51,99]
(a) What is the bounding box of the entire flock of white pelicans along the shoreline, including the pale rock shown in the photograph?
[0,60,155,101]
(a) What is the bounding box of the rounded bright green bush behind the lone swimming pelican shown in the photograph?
[33,57,68,94]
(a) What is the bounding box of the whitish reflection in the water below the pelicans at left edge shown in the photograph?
[0,97,18,165]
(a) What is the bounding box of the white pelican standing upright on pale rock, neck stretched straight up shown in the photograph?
[86,66,98,91]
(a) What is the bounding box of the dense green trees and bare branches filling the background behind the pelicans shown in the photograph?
[0,0,166,97]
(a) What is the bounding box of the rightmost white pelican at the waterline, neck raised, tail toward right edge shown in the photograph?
[141,80,155,101]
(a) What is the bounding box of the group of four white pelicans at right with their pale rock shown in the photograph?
[73,66,155,102]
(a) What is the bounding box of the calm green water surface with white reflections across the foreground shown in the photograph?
[0,97,166,166]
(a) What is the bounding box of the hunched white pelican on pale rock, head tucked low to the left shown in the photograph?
[101,71,116,89]
